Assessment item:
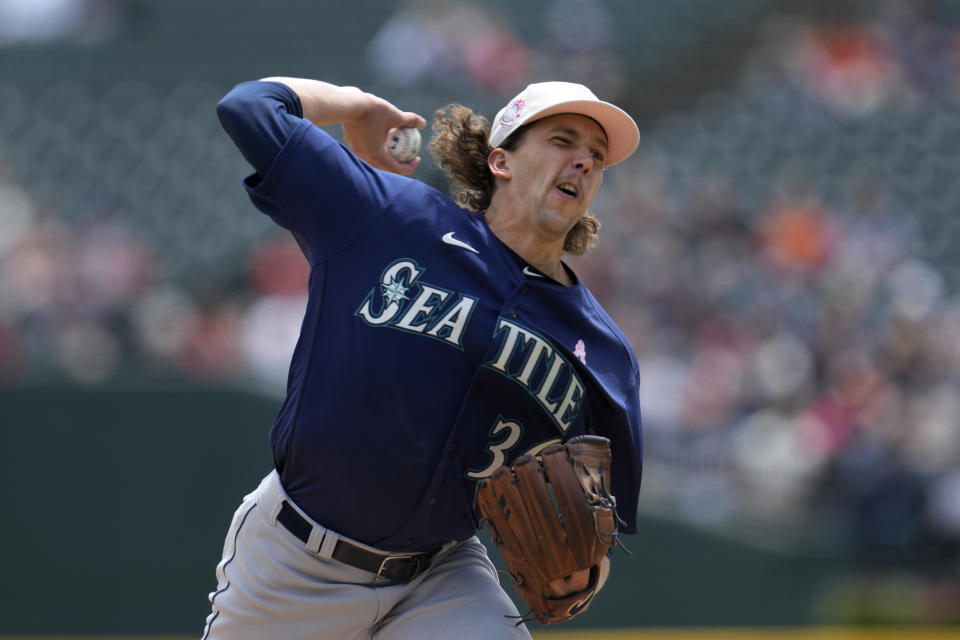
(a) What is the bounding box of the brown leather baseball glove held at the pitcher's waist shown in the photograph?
[477,436,618,624]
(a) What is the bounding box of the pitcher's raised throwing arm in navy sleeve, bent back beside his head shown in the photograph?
[217,78,422,263]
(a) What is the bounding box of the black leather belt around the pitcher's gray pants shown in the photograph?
[277,500,440,583]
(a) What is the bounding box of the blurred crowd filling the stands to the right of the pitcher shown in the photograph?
[589,3,960,575]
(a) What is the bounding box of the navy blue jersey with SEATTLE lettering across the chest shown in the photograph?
[214,83,641,550]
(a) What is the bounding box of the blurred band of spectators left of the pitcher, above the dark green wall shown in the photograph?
[0,170,308,393]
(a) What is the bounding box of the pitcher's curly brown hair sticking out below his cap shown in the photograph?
[430,104,600,256]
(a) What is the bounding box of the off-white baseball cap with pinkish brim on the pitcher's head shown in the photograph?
[490,82,640,167]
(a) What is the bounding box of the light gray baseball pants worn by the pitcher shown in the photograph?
[203,471,531,640]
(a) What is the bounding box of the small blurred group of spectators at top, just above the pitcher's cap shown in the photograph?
[367,0,627,100]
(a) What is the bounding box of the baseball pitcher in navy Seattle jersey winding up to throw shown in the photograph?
[204,78,641,640]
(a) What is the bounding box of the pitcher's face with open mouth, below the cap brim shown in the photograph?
[508,113,607,235]
